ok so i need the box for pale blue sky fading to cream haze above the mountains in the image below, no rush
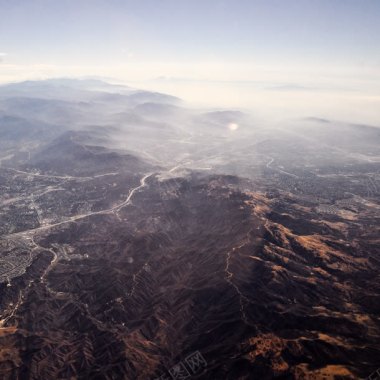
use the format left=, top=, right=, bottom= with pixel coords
left=0, top=0, right=380, bottom=124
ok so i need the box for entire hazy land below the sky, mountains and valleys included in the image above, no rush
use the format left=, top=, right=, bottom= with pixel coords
left=0, top=81, right=380, bottom=380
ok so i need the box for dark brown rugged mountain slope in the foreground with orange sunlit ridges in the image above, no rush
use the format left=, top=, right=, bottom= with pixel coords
left=0, top=175, right=380, bottom=380
